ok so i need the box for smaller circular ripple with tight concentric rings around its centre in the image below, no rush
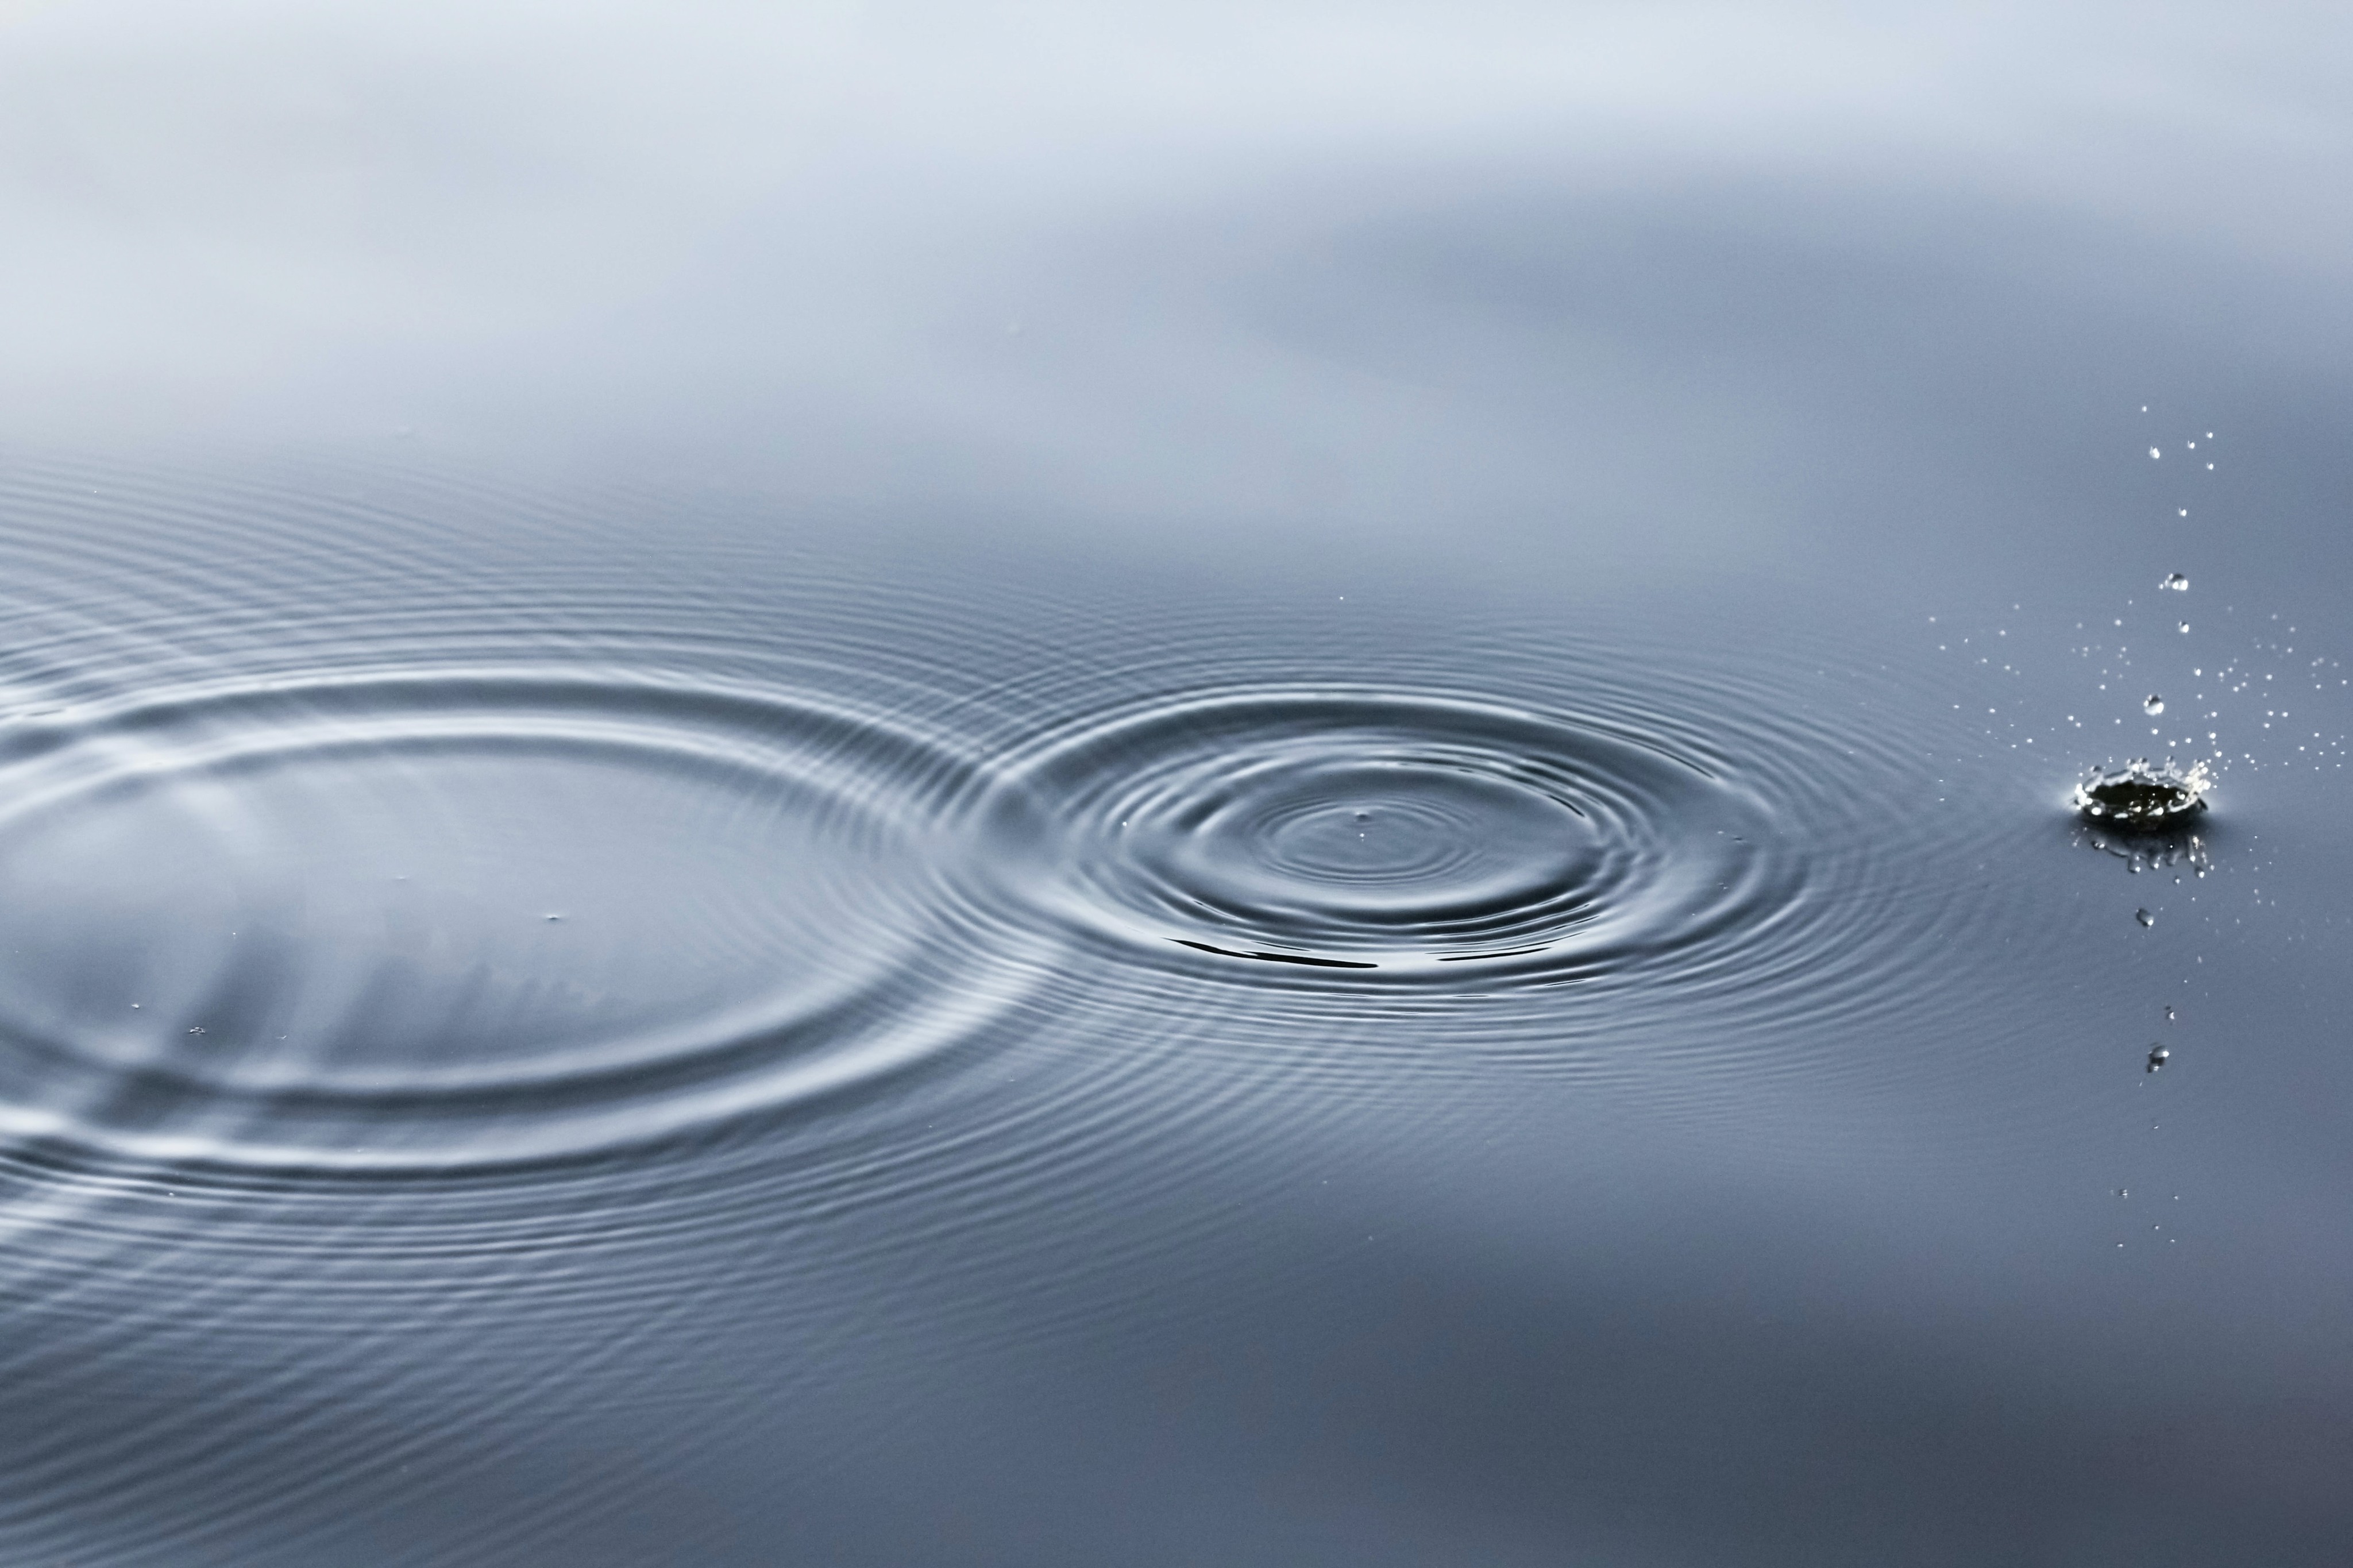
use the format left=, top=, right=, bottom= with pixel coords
left=988, top=689, right=1805, bottom=985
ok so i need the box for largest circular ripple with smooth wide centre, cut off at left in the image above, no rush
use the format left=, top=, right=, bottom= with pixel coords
left=0, top=673, right=1021, bottom=1171
